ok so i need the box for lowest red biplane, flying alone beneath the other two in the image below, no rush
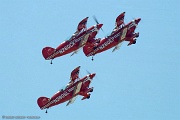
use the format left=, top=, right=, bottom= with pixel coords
left=37, top=66, right=96, bottom=113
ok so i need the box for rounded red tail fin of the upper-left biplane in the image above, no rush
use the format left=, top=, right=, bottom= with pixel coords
left=42, top=47, right=56, bottom=60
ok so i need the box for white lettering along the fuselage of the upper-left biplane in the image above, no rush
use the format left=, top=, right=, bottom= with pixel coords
left=47, top=26, right=98, bottom=60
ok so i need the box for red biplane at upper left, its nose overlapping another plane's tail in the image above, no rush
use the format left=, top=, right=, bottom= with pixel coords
left=42, top=17, right=103, bottom=64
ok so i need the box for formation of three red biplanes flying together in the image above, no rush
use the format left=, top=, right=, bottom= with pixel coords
left=37, top=12, right=141, bottom=112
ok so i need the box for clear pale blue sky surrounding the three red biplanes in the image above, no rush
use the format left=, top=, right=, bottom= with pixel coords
left=0, top=0, right=180, bottom=120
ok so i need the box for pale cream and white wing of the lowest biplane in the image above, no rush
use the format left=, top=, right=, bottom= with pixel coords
left=66, top=82, right=82, bottom=106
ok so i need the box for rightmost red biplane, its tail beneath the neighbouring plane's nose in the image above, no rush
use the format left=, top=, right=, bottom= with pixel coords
left=83, top=12, right=141, bottom=60
